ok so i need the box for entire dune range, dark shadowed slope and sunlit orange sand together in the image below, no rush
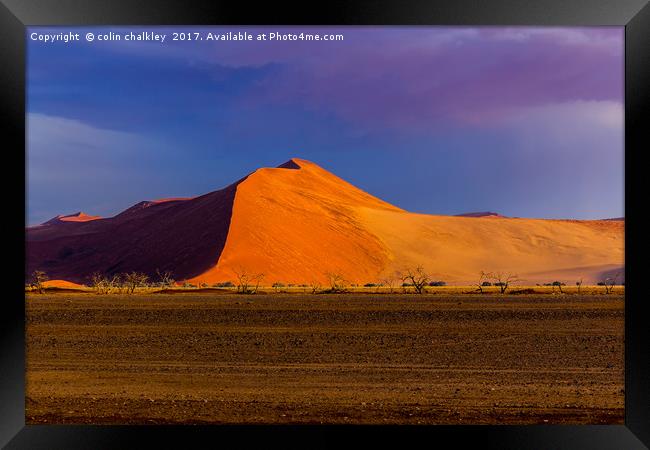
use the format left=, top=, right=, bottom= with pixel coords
left=27, top=159, right=624, bottom=284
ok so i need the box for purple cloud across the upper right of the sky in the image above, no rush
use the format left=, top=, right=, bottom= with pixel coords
left=214, top=28, right=623, bottom=133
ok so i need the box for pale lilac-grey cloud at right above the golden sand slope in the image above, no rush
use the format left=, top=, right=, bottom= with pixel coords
left=470, top=101, right=624, bottom=219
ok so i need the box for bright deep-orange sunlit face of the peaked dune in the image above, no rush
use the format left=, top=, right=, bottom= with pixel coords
left=193, top=159, right=401, bottom=283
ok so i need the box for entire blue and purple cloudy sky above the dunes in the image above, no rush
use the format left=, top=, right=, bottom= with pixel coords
left=26, top=27, right=624, bottom=225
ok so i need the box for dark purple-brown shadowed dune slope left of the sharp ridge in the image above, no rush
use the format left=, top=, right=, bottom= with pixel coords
left=27, top=183, right=236, bottom=282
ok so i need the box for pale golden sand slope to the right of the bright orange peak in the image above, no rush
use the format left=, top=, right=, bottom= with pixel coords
left=361, top=209, right=624, bottom=284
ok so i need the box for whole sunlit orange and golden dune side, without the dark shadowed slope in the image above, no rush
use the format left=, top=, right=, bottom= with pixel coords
left=186, top=159, right=624, bottom=284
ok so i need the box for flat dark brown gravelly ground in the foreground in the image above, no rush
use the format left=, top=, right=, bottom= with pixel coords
left=26, top=293, right=624, bottom=424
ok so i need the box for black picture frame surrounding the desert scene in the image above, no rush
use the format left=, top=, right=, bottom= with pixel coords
left=0, top=0, right=650, bottom=449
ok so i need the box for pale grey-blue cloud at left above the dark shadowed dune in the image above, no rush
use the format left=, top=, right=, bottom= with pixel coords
left=26, top=113, right=170, bottom=224
